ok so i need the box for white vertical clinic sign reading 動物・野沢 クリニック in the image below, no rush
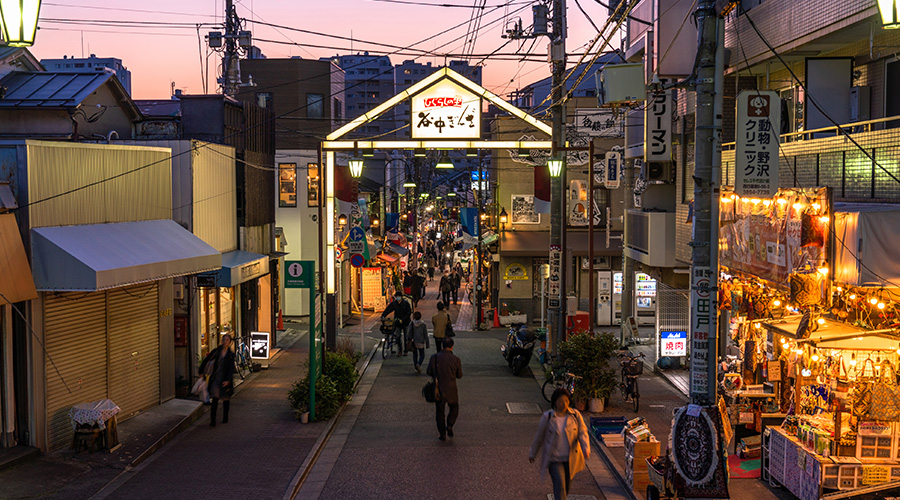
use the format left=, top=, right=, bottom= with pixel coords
left=734, top=90, right=781, bottom=198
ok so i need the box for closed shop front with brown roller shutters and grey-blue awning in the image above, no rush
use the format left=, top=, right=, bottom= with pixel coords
left=31, top=220, right=221, bottom=451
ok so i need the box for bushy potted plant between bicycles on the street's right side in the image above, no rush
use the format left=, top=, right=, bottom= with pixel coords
left=559, top=332, right=619, bottom=412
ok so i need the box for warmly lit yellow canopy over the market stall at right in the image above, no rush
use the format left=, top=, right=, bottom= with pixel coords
left=762, top=315, right=900, bottom=351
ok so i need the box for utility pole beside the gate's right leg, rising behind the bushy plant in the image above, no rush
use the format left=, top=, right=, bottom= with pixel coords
left=550, top=0, right=568, bottom=355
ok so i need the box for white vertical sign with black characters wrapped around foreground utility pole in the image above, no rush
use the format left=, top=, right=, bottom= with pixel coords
left=691, top=266, right=712, bottom=400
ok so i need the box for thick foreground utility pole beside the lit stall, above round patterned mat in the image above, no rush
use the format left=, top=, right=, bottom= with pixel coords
left=690, top=0, right=724, bottom=406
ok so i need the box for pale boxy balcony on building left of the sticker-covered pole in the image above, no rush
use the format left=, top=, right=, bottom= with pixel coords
left=625, top=210, right=675, bottom=267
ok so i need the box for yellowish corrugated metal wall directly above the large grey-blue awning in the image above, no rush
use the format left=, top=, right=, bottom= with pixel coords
left=27, top=141, right=172, bottom=227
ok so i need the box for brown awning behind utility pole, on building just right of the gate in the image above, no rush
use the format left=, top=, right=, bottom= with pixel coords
left=500, top=230, right=622, bottom=257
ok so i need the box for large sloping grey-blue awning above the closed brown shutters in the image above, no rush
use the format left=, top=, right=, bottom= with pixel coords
left=31, top=219, right=222, bottom=292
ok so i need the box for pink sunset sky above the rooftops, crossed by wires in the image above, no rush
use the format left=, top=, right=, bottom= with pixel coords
left=31, top=0, right=618, bottom=99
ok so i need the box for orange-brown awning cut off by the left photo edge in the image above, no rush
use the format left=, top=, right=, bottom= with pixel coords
left=0, top=214, right=37, bottom=305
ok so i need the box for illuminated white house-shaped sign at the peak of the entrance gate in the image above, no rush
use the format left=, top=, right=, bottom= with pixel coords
left=410, top=78, right=481, bottom=139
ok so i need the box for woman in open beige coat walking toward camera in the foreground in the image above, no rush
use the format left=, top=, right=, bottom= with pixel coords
left=528, top=389, right=591, bottom=500
